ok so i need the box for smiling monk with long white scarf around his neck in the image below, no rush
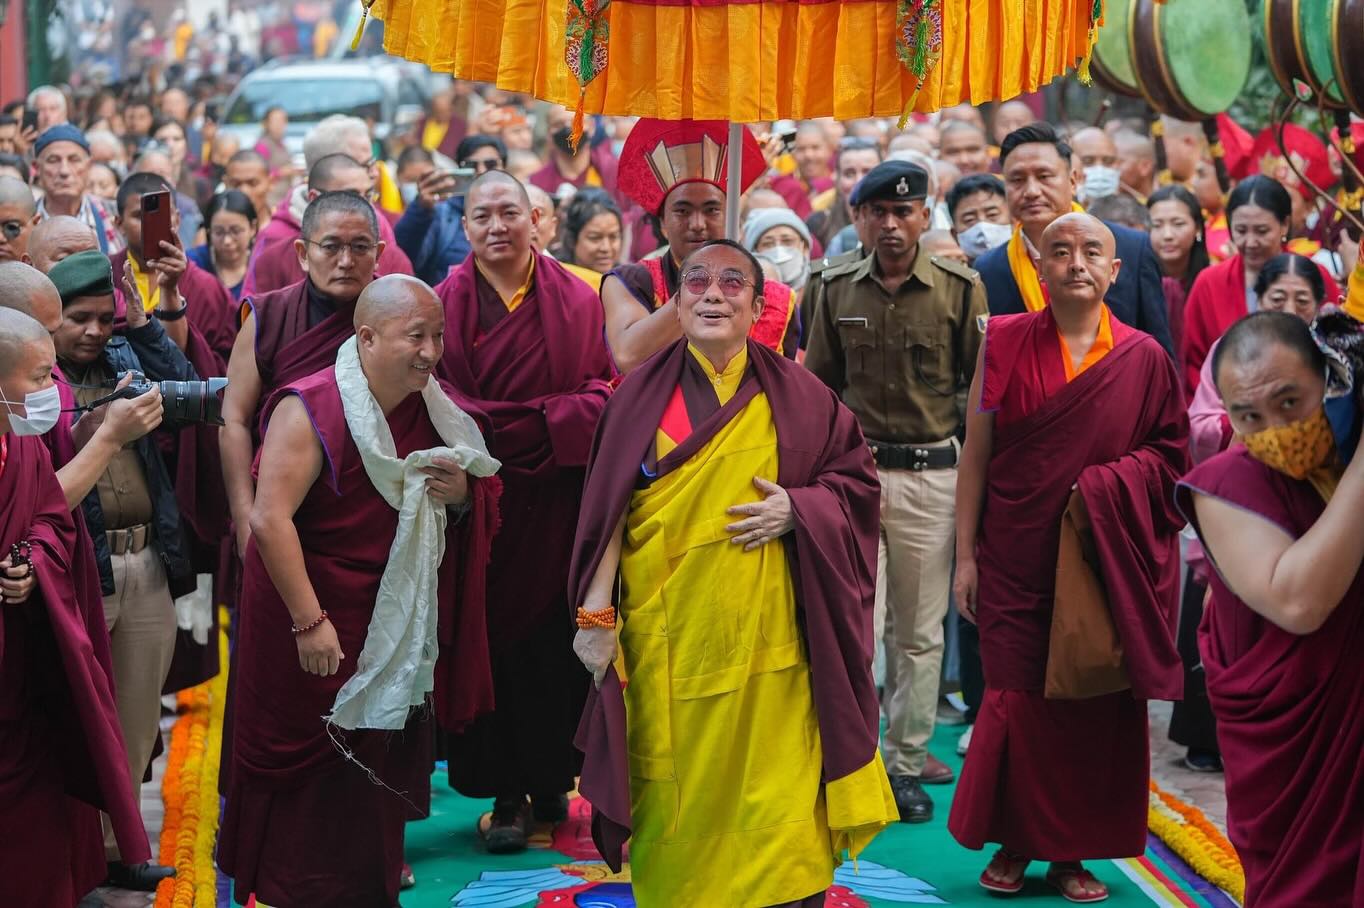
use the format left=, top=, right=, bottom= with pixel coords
left=218, top=272, right=498, bottom=908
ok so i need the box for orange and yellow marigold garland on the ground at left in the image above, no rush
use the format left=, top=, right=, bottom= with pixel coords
left=155, top=615, right=228, bottom=908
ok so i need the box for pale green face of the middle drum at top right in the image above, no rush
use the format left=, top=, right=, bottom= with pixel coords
left=1157, top=0, right=1251, bottom=116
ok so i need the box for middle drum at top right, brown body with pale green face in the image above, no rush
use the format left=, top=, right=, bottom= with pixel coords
left=1123, top=0, right=1249, bottom=120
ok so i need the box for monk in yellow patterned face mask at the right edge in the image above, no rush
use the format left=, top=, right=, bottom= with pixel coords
left=1178, top=312, right=1364, bottom=908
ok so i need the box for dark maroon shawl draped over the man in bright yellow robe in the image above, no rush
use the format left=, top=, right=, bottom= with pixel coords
left=569, top=338, right=881, bottom=868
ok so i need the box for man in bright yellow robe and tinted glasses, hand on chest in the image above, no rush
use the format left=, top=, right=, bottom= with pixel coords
left=570, top=240, right=899, bottom=908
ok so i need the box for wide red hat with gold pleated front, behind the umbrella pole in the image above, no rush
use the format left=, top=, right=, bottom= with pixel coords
left=617, top=119, right=767, bottom=215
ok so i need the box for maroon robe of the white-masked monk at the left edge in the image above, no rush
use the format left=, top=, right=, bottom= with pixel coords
left=0, top=434, right=151, bottom=908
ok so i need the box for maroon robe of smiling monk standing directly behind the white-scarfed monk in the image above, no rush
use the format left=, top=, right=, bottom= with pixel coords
left=436, top=255, right=611, bottom=640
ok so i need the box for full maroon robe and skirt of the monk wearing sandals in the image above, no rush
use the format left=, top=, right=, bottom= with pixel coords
left=948, top=308, right=1188, bottom=862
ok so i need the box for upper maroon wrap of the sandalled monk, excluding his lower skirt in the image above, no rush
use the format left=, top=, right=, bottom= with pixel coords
left=977, top=308, right=1188, bottom=699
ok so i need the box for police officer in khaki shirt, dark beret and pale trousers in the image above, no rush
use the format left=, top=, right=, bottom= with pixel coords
left=805, top=161, right=989, bottom=822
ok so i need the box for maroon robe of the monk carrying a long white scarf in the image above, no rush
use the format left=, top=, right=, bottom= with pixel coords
left=218, top=368, right=496, bottom=908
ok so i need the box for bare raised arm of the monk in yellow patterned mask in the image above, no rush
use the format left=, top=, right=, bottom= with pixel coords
left=1194, top=444, right=1364, bottom=634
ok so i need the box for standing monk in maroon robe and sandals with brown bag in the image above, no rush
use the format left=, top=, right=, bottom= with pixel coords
left=948, top=214, right=1188, bottom=901
